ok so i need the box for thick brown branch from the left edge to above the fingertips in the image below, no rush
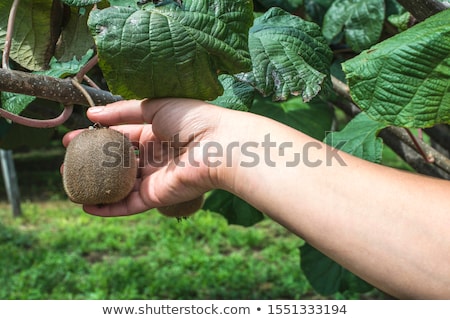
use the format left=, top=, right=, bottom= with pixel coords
left=0, top=69, right=122, bottom=106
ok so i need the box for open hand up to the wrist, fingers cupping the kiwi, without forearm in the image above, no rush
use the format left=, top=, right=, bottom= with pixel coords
left=63, top=99, right=225, bottom=216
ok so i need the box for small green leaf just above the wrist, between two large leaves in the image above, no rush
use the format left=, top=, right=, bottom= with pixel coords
left=211, top=74, right=255, bottom=111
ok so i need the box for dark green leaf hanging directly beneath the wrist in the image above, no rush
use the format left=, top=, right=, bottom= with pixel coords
left=203, top=190, right=264, bottom=227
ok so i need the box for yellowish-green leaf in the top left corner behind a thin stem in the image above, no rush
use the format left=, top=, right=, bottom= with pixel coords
left=0, top=0, right=62, bottom=70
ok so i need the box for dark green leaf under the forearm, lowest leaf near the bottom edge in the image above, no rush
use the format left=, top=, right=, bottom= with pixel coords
left=300, top=243, right=373, bottom=295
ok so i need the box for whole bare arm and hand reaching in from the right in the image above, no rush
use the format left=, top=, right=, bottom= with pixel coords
left=64, top=99, right=450, bottom=298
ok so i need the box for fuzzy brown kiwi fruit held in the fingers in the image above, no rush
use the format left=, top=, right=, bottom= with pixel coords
left=63, top=128, right=137, bottom=205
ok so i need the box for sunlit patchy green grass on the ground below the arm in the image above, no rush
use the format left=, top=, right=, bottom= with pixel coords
left=0, top=201, right=316, bottom=299
